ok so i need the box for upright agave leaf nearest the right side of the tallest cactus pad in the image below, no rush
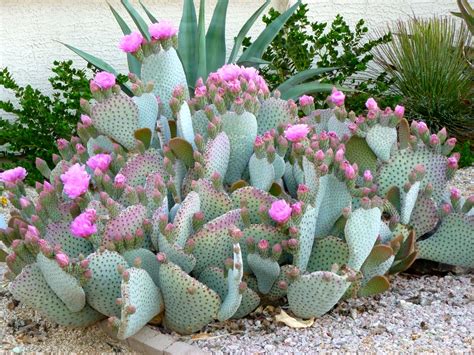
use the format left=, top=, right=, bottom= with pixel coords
left=178, top=0, right=197, bottom=86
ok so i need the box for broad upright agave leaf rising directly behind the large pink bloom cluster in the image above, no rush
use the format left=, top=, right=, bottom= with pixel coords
left=206, top=0, right=229, bottom=73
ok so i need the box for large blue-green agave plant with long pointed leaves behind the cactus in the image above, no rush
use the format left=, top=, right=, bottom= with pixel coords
left=63, top=0, right=334, bottom=97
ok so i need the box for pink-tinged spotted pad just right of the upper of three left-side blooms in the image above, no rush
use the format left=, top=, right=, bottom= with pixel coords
left=119, top=149, right=166, bottom=187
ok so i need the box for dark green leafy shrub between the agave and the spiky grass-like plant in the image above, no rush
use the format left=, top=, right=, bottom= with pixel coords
left=244, top=4, right=393, bottom=110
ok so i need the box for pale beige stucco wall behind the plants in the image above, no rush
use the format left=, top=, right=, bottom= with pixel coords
left=0, top=0, right=456, bottom=97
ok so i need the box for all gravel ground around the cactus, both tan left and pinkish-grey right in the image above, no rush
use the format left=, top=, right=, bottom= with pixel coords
left=0, top=167, right=474, bottom=354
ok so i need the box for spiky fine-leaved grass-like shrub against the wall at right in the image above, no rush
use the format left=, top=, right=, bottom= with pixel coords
left=374, top=18, right=474, bottom=142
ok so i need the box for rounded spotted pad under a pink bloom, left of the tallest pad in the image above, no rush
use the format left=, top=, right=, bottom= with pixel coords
left=91, top=94, right=139, bottom=149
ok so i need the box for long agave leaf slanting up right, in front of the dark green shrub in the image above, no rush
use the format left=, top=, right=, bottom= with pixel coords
left=237, top=0, right=301, bottom=63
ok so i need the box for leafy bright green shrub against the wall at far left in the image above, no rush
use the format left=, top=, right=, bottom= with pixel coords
left=0, top=61, right=90, bottom=183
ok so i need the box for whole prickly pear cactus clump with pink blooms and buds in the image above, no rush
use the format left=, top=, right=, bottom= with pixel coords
left=0, top=23, right=474, bottom=339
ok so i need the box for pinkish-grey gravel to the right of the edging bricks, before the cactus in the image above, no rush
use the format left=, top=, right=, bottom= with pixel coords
left=182, top=275, right=474, bottom=354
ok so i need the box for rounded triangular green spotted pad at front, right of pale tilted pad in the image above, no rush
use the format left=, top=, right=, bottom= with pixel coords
left=160, top=262, right=221, bottom=334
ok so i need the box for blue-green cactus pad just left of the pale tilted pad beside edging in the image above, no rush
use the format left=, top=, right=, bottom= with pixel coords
left=84, top=250, right=128, bottom=317
